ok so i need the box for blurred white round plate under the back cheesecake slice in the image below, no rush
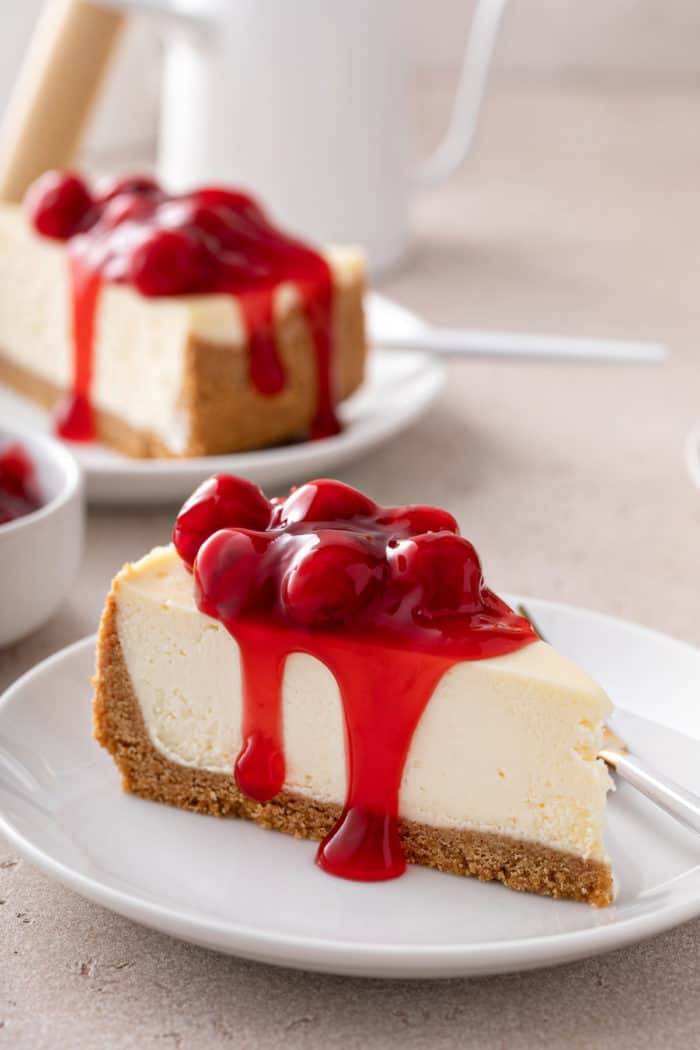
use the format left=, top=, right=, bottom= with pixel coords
left=0, top=349, right=446, bottom=504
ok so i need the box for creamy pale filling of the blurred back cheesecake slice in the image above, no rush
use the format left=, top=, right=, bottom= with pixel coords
left=0, top=205, right=363, bottom=455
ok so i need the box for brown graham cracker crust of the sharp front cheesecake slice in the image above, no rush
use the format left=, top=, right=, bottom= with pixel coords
left=93, top=591, right=613, bottom=907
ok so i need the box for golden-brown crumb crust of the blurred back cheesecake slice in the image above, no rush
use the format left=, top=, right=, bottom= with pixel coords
left=0, top=280, right=366, bottom=459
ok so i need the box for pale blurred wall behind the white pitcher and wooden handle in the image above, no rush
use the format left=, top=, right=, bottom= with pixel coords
left=8, top=0, right=700, bottom=177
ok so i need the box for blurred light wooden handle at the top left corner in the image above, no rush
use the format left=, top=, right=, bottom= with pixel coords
left=0, top=0, right=125, bottom=202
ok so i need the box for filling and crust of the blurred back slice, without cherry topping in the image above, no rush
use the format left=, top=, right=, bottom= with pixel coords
left=0, top=204, right=366, bottom=459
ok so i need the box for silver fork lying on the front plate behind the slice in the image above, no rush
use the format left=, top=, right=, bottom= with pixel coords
left=517, top=605, right=700, bottom=833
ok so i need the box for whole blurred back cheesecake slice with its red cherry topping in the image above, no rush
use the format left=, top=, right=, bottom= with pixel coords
left=0, top=173, right=365, bottom=457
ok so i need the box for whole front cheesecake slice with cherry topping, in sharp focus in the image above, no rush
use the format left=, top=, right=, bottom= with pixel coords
left=94, top=477, right=612, bottom=906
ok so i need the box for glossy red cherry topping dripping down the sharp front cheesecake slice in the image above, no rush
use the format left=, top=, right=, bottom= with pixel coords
left=173, top=475, right=536, bottom=881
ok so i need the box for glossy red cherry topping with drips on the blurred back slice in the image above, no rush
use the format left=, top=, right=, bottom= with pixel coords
left=26, top=171, right=340, bottom=441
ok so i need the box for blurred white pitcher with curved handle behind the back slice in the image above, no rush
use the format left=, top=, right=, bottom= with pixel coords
left=92, top=0, right=506, bottom=271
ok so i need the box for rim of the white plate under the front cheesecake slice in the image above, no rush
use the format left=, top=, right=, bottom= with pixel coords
left=0, top=595, right=700, bottom=978
